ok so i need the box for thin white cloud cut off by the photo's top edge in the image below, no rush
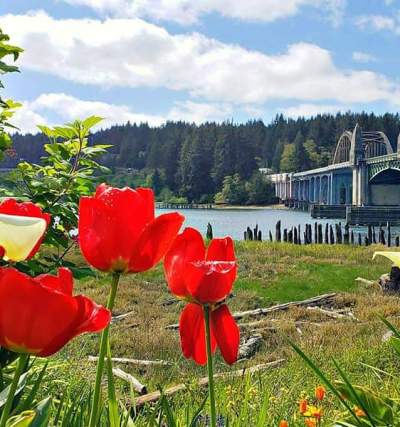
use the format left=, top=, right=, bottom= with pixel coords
left=64, top=0, right=346, bottom=25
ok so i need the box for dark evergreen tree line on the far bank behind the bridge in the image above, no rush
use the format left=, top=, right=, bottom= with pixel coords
left=1, top=112, right=400, bottom=204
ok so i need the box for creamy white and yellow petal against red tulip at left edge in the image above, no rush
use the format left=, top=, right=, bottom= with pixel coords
left=0, top=214, right=47, bottom=261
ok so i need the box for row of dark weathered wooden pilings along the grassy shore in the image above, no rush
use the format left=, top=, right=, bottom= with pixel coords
left=244, top=221, right=400, bottom=247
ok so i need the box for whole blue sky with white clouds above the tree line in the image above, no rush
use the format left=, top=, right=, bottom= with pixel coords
left=0, top=0, right=400, bottom=133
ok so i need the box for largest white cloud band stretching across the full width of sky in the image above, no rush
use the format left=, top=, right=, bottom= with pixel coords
left=0, top=12, right=400, bottom=105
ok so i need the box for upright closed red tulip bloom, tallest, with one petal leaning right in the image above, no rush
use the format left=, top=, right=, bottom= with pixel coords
left=79, top=184, right=184, bottom=273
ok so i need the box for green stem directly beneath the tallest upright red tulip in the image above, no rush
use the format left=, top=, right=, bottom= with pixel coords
left=90, top=273, right=120, bottom=427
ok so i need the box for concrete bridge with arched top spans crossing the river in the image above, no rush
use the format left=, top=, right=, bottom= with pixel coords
left=270, top=125, right=400, bottom=222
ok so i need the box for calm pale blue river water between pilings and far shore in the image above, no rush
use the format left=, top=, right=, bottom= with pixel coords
left=157, top=209, right=339, bottom=240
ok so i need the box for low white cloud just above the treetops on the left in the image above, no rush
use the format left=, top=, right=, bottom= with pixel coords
left=13, top=93, right=232, bottom=133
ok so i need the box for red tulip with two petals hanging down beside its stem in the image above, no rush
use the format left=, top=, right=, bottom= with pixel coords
left=164, top=228, right=239, bottom=365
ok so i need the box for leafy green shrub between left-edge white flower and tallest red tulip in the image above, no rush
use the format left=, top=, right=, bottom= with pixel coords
left=3, top=116, right=110, bottom=277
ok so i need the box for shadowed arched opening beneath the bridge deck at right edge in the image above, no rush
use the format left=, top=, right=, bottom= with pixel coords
left=369, top=167, right=400, bottom=206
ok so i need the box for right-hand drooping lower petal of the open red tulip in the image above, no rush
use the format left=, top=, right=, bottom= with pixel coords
left=211, top=304, right=240, bottom=365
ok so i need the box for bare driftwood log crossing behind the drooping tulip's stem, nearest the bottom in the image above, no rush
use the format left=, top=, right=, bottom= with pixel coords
left=135, top=359, right=285, bottom=407
